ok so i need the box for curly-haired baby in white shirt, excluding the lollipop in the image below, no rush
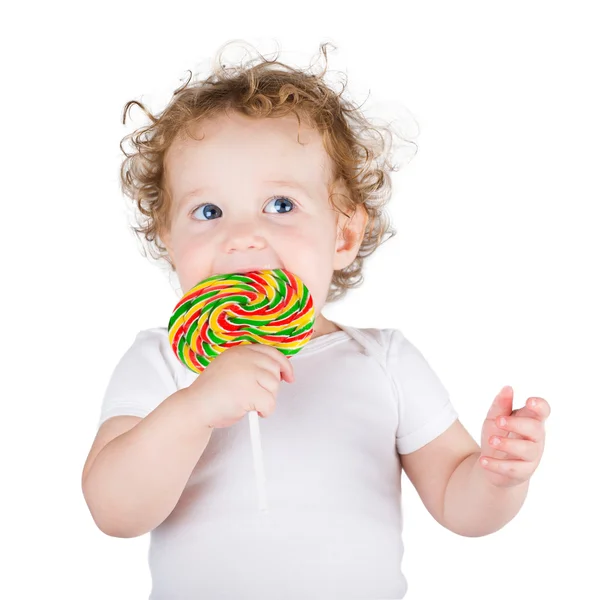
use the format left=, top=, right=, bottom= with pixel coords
left=82, top=46, right=550, bottom=600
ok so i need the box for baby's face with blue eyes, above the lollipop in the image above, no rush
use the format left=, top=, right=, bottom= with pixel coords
left=162, top=113, right=355, bottom=315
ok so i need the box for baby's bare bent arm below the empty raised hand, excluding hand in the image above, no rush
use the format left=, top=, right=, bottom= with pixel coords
left=401, top=420, right=527, bottom=537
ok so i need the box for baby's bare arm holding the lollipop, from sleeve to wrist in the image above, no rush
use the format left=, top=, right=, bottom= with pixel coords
left=82, top=390, right=213, bottom=537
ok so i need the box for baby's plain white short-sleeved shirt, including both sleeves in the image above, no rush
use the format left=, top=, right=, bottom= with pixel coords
left=99, top=323, right=458, bottom=600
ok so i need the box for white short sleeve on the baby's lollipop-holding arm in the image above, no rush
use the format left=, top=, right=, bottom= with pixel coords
left=98, top=328, right=178, bottom=427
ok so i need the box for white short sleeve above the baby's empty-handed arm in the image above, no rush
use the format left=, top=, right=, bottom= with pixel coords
left=387, top=330, right=458, bottom=454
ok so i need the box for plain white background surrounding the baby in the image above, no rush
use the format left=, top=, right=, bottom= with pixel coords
left=0, top=1, right=600, bottom=600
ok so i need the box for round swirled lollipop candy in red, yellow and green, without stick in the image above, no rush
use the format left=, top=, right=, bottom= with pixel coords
left=168, top=269, right=315, bottom=373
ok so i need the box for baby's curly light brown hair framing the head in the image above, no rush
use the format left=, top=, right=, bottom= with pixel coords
left=120, top=42, right=414, bottom=302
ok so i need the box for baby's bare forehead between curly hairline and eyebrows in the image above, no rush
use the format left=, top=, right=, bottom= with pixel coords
left=165, top=113, right=330, bottom=197
